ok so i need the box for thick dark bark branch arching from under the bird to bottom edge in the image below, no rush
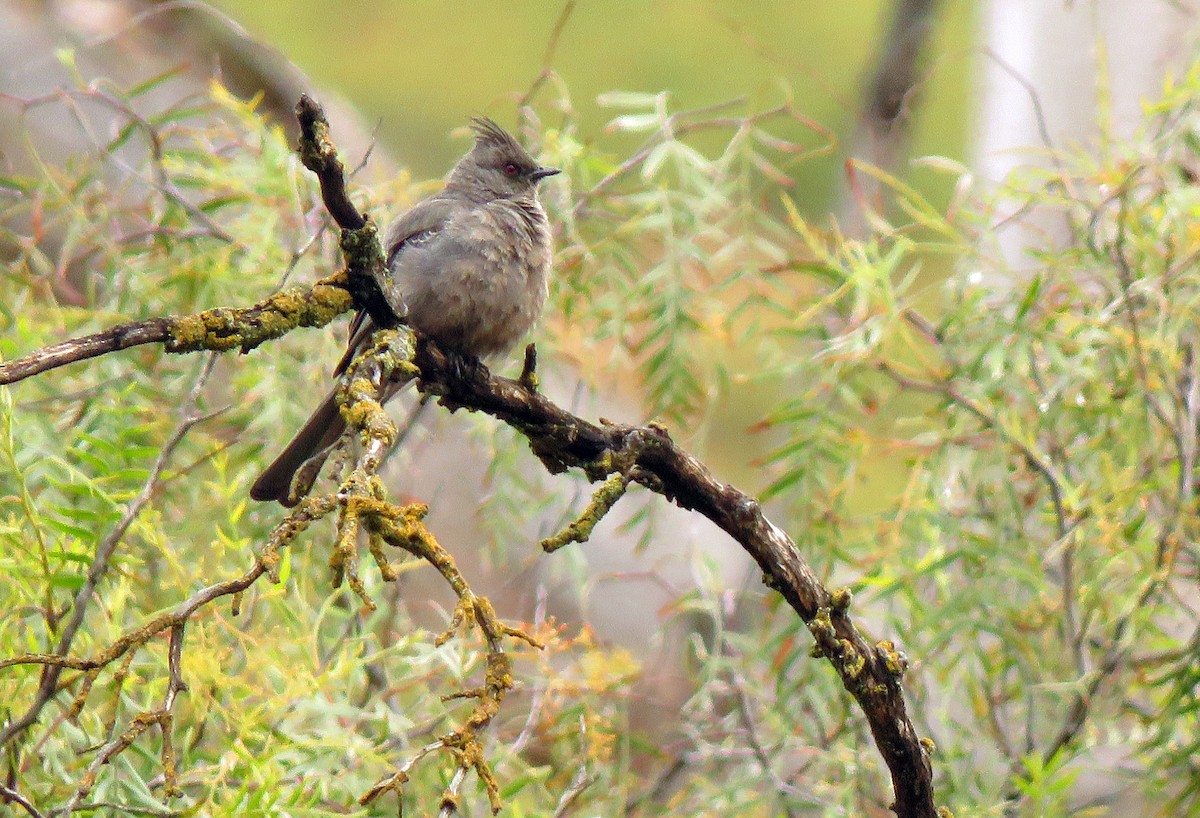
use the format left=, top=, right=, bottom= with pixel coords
left=414, top=341, right=937, bottom=818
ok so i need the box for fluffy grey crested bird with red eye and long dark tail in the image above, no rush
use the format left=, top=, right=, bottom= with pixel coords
left=250, top=119, right=558, bottom=507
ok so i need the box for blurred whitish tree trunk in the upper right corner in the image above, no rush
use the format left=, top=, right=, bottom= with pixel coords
left=972, top=0, right=1200, bottom=280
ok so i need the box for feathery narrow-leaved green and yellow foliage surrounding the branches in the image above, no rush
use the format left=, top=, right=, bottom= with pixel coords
left=0, top=36, right=1200, bottom=816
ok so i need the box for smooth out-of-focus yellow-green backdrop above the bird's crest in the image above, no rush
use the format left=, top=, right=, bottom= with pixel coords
left=206, top=0, right=974, bottom=213
